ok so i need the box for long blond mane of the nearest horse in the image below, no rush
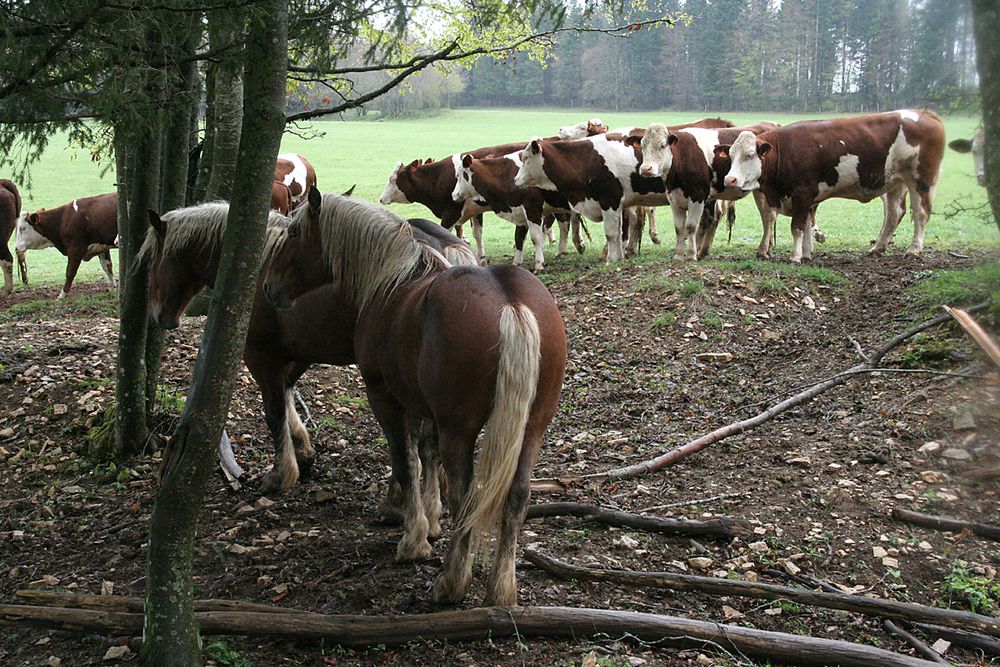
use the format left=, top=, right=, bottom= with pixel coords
left=308, top=194, right=451, bottom=311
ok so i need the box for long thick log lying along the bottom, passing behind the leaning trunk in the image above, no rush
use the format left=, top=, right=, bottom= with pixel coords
left=0, top=605, right=935, bottom=667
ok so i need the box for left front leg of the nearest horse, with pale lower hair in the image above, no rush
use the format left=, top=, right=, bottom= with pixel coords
left=368, top=383, right=431, bottom=561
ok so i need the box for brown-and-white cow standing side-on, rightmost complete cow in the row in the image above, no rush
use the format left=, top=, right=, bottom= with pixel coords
left=717, top=109, right=944, bottom=262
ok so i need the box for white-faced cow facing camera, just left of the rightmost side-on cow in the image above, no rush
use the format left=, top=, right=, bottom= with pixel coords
left=625, top=122, right=779, bottom=259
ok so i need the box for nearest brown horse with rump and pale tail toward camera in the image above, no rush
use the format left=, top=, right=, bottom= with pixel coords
left=264, top=190, right=566, bottom=605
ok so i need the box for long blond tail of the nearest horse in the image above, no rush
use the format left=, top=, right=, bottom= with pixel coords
left=459, top=304, right=542, bottom=540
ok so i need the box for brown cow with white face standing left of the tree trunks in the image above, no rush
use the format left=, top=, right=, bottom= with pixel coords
left=15, top=192, right=118, bottom=299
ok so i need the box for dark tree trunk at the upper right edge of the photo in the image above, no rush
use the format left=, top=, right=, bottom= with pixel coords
left=972, top=0, right=1000, bottom=235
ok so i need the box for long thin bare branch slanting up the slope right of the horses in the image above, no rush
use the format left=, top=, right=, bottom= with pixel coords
left=531, top=302, right=989, bottom=491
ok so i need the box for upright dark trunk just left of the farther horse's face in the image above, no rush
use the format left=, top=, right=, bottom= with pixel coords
left=115, top=116, right=160, bottom=456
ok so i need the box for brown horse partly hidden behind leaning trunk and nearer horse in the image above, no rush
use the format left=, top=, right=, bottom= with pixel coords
left=139, top=202, right=476, bottom=494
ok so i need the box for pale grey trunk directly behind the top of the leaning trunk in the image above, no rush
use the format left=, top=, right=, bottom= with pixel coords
left=205, top=9, right=245, bottom=201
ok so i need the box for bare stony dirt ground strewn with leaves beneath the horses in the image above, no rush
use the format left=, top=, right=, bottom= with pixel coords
left=0, top=248, right=1000, bottom=666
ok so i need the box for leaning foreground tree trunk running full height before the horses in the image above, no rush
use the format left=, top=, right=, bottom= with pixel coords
left=143, top=0, right=288, bottom=667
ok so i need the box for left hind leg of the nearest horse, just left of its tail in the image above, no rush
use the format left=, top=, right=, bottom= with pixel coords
left=432, top=431, right=478, bottom=604
